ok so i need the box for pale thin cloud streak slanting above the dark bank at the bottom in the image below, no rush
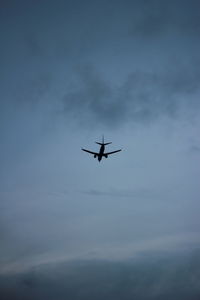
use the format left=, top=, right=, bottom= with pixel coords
left=0, top=233, right=199, bottom=274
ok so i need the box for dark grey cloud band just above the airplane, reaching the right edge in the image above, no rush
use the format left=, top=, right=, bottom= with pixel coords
left=63, top=65, right=200, bottom=126
